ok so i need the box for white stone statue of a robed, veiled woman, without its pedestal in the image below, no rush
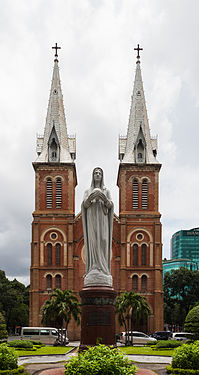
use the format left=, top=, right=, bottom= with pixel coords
left=82, top=167, right=113, bottom=286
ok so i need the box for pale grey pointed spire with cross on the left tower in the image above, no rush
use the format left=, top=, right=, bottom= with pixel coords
left=36, top=43, right=75, bottom=163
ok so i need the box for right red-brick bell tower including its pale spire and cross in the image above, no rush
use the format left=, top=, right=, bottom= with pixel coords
left=117, top=44, right=163, bottom=332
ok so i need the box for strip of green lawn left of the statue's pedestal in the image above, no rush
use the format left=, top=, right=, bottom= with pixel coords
left=15, top=346, right=72, bottom=357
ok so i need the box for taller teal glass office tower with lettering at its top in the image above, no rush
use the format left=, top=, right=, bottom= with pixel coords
left=171, top=228, right=199, bottom=266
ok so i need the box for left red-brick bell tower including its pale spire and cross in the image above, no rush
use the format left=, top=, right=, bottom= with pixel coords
left=29, top=43, right=77, bottom=326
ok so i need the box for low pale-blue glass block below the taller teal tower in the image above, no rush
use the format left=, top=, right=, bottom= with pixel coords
left=162, top=259, right=198, bottom=277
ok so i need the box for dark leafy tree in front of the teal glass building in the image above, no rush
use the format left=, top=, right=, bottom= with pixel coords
left=164, top=267, right=199, bottom=327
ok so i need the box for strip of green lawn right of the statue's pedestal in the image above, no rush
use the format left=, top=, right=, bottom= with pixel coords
left=118, top=346, right=173, bottom=357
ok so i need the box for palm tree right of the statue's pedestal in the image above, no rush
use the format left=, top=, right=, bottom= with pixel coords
left=115, top=291, right=150, bottom=345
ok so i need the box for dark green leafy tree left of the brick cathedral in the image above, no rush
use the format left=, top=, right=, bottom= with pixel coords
left=0, top=270, right=29, bottom=332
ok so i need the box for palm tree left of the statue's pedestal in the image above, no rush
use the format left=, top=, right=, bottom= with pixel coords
left=41, top=289, right=81, bottom=344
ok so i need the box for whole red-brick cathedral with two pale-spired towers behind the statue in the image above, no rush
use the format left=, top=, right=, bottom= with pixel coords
left=29, top=44, right=163, bottom=340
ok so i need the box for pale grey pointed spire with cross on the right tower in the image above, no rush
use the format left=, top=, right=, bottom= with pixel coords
left=119, top=44, right=159, bottom=164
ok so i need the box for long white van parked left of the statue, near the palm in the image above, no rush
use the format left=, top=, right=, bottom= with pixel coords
left=21, top=327, right=69, bottom=345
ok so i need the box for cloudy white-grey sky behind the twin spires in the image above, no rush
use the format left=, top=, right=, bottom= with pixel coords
left=0, top=0, right=199, bottom=284
